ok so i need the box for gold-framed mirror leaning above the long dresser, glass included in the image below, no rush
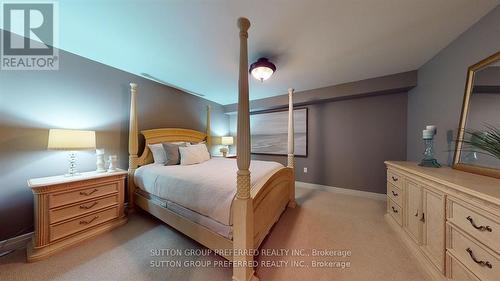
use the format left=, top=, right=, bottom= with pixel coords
left=453, top=52, right=500, bottom=178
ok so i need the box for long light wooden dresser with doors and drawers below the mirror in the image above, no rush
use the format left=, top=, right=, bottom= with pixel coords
left=385, top=161, right=500, bottom=281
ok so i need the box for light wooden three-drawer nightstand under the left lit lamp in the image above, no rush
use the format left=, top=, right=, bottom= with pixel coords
left=27, top=170, right=127, bottom=262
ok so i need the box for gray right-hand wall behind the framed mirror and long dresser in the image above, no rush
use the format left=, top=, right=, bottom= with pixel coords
left=407, top=6, right=500, bottom=164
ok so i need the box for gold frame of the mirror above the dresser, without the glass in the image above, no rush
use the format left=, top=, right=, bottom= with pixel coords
left=453, top=52, right=500, bottom=178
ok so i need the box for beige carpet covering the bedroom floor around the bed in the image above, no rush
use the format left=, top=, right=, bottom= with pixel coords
left=0, top=186, right=428, bottom=281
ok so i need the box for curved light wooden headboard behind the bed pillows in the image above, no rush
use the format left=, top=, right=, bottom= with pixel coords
left=137, top=128, right=208, bottom=166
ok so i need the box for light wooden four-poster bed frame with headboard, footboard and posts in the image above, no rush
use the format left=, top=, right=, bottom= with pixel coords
left=128, top=18, right=296, bottom=281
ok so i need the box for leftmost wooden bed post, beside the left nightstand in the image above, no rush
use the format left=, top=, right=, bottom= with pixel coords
left=128, top=83, right=139, bottom=210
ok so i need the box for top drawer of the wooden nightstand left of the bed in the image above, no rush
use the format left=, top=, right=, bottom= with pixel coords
left=49, top=182, right=118, bottom=208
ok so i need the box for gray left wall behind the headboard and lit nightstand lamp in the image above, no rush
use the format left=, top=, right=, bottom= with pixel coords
left=0, top=42, right=228, bottom=241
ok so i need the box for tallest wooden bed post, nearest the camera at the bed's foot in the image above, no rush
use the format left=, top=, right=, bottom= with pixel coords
left=233, top=18, right=259, bottom=281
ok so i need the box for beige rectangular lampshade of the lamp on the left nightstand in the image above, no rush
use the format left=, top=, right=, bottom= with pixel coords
left=48, top=129, right=95, bottom=150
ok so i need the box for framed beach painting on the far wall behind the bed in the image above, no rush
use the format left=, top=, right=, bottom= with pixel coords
left=250, top=108, right=307, bottom=156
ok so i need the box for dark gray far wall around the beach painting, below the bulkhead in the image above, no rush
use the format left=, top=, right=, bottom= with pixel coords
left=230, top=93, right=407, bottom=193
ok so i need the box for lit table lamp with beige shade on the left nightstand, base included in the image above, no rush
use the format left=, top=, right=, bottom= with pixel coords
left=47, top=129, right=95, bottom=177
